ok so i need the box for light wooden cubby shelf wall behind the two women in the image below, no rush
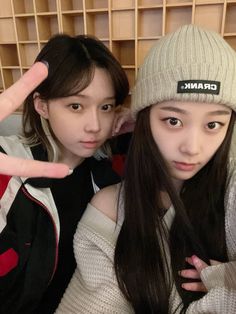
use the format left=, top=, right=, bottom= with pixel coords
left=0, top=0, right=236, bottom=106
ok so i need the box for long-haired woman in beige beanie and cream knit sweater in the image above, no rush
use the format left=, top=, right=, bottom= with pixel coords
left=57, top=25, right=236, bottom=314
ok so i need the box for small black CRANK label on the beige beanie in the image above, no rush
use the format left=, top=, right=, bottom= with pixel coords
left=177, top=80, right=220, bottom=95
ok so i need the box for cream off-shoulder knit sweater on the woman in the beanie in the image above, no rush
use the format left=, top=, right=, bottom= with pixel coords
left=56, top=163, right=236, bottom=314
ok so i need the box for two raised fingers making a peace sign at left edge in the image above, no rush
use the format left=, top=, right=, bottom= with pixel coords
left=0, top=62, right=69, bottom=178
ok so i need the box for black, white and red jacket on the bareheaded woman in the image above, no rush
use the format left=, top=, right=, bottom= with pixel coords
left=0, top=136, right=126, bottom=314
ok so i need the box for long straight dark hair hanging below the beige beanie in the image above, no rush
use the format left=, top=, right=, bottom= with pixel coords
left=115, top=107, right=235, bottom=314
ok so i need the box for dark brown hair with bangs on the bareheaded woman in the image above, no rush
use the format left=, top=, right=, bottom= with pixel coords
left=23, top=34, right=129, bottom=159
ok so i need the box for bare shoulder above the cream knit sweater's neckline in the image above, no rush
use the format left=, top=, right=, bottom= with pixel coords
left=90, top=184, right=120, bottom=222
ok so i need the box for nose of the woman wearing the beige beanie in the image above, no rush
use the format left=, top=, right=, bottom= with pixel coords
left=179, top=129, right=201, bottom=156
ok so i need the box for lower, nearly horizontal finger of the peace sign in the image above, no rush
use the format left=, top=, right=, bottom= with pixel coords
left=0, top=153, right=69, bottom=178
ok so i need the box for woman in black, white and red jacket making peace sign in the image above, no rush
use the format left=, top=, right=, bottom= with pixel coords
left=0, top=34, right=129, bottom=314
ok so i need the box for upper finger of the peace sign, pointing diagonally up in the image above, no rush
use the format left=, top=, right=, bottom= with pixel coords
left=0, top=62, right=48, bottom=121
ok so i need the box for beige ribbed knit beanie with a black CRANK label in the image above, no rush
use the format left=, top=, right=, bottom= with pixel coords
left=131, top=25, right=236, bottom=115
